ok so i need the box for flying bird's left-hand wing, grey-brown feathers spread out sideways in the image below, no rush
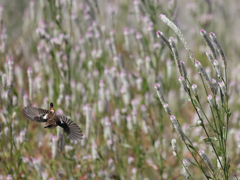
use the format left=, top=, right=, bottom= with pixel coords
left=22, top=106, right=49, bottom=122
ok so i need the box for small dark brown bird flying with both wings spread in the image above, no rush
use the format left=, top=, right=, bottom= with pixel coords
left=22, top=103, right=83, bottom=141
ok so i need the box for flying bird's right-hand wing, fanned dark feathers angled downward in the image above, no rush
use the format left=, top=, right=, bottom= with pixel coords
left=56, top=114, right=82, bottom=141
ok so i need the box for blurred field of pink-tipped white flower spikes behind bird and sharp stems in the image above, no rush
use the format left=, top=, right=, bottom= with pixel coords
left=0, top=0, right=240, bottom=180
